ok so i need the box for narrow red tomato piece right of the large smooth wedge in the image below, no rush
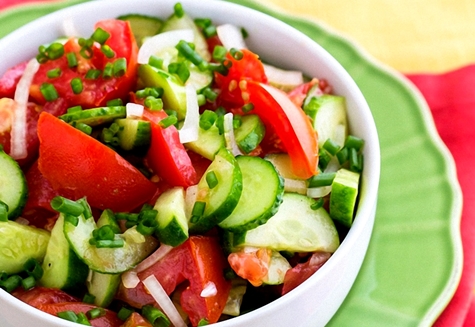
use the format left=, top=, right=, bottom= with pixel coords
left=143, top=110, right=198, bottom=187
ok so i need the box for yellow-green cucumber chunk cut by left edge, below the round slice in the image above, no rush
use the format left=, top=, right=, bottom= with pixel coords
left=0, top=221, right=50, bottom=275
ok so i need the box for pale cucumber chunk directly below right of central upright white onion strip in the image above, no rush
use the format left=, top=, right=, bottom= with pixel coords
left=184, top=125, right=226, bottom=160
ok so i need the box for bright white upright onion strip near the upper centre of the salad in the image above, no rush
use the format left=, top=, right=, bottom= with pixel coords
left=178, top=85, right=200, bottom=143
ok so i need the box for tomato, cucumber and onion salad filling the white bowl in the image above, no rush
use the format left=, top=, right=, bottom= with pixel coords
left=0, top=3, right=364, bottom=327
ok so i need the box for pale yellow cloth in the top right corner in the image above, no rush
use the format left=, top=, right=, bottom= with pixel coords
left=260, top=0, right=475, bottom=73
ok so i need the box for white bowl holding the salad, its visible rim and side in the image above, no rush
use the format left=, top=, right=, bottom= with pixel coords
left=0, top=0, right=380, bottom=327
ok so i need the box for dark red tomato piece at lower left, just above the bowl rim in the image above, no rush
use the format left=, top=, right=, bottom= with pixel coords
left=12, top=286, right=79, bottom=308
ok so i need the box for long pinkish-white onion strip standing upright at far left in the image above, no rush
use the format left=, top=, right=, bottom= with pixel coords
left=10, top=58, right=40, bottom=159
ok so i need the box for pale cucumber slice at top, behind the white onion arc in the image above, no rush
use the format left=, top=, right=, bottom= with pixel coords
left=160, top=10, right=211, bottom=61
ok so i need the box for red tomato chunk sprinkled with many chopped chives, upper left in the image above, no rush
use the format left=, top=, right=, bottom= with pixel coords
left=30, top=19, right=138, bottom=108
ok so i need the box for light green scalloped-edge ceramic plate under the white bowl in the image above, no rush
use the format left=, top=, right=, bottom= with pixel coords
left=0, top=0, right=462, bottom=326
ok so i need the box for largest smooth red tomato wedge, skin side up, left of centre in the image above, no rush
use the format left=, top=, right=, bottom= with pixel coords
left=38, top=112, right=157, bottom=211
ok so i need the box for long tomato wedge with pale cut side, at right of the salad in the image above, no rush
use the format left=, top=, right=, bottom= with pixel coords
left=246, top=81, right=318, bottom=179
